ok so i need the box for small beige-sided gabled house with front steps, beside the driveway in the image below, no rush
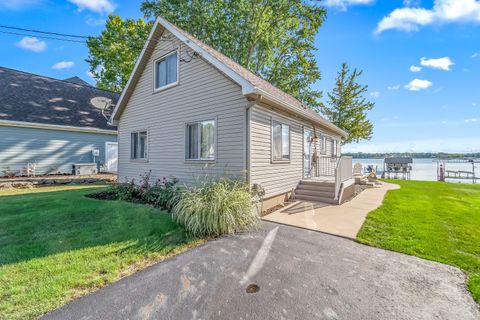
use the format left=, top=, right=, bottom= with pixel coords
left=111, top=17, right=353, bottom=208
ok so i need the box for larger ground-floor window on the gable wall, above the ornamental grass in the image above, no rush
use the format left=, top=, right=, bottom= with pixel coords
left=185, top=120, right=215, bottom=161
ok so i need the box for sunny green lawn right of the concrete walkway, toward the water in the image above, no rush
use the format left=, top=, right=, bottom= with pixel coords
left=357, top=181, right=480, bottom=302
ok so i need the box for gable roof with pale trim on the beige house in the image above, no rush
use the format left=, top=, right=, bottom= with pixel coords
left=110, top=17, right=347, bottom=136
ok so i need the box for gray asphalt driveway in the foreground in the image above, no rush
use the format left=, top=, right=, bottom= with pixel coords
left=45, top=223, right=480, bottom=320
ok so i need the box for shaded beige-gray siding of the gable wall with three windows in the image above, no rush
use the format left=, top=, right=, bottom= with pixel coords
left=118, top=30, right=247, bottom=183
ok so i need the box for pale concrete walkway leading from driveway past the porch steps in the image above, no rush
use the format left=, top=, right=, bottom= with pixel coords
left=262, top=182, right=400, bottom=239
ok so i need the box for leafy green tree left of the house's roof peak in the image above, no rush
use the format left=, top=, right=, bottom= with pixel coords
left=86, top=15, right=152, bottom=92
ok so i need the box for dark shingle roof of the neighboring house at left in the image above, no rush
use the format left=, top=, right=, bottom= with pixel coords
left=0, top=67, right=119, bottom=130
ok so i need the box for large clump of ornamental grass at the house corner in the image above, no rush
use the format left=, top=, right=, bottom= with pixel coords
left=172, top=179, right=258, bottom=236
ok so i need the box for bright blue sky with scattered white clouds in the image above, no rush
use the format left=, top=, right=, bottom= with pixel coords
left=0, top=0, right=480, bottom=152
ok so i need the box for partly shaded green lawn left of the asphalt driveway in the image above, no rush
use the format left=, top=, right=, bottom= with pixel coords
left=0, top=186, right=200, bottom=319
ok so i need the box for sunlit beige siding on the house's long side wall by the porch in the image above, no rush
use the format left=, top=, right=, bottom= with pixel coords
left=250, top=105, right=340, bottom=198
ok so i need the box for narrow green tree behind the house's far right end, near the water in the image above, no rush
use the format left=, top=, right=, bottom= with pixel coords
left=322, top=63, right=375, bottom=143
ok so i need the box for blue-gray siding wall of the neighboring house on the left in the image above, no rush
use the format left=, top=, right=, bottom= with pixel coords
left=0, top=126, right=117, bottom=176
